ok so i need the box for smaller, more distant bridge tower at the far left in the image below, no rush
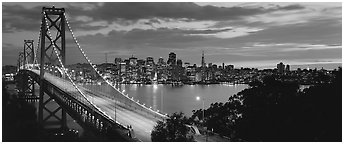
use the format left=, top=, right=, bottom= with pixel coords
left=21, top=40, right=37, bottom=99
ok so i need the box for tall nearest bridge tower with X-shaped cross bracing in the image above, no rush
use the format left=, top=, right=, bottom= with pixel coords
left=38, top=7, right=67, bottom=129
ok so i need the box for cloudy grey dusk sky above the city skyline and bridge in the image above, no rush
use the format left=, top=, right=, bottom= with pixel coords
left=2, top=2, right=342, bottom=67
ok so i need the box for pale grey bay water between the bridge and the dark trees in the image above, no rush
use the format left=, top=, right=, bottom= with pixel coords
left=107, top=84, right=248, bottom=116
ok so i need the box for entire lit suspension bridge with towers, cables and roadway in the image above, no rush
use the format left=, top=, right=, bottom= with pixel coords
left=17, top=7, right=168, bottom=141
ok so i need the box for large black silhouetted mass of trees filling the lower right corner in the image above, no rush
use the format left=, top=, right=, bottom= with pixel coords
left=192, top=69, right=342, bottom=141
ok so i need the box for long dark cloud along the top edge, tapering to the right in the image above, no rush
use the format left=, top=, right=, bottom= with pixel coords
left=76, top=2, right=303, bottom=21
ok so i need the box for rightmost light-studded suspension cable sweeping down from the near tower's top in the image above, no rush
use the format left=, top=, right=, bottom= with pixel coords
left=64, top=13, right=167, bottom=117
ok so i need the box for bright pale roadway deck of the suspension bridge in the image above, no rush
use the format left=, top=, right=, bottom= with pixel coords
left=31, top=70, right=163, bottom=142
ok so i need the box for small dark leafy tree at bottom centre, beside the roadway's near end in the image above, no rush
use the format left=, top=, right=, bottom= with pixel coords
left=151, top=112, right=194, bottom=142
